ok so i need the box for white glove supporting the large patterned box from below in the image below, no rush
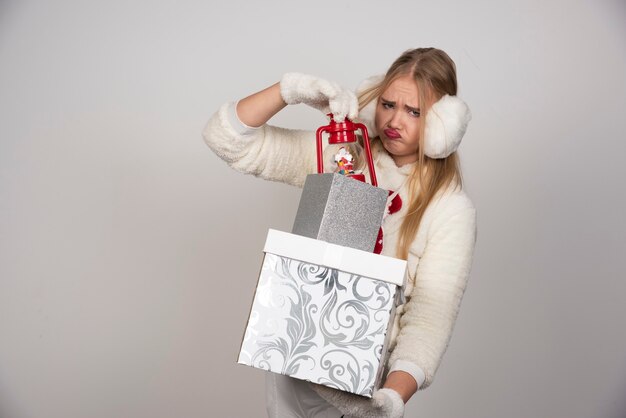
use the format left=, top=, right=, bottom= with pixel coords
left=311, top=383, right=404, bottom=418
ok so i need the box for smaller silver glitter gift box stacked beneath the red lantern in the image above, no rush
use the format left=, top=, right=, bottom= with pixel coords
left=292, top=174, right=388, bottom=252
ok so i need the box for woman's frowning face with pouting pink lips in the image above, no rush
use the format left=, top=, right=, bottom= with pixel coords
left=375, top=74, right=422, bottom=167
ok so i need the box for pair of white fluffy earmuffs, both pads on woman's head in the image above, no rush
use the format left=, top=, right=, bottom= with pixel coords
left=356, top=75, right=472, bottom=158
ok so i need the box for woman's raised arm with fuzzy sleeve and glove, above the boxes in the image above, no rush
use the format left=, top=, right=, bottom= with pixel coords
left=203, top=73, right=358, bottom=186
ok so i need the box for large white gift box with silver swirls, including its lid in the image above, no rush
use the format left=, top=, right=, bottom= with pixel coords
left=238, top=230, right=406, bottom=397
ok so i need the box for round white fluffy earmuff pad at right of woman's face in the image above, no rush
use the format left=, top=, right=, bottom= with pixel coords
left=424, top=94, right=472, bottom=158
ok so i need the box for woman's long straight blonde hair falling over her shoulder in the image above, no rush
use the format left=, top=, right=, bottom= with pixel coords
left=359, top=48, right=463, bottom=260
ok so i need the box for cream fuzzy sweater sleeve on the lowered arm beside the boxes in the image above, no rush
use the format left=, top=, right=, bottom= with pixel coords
left=389, top=202, right=476, bottom=389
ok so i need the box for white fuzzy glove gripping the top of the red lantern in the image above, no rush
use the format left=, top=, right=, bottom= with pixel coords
left=280, top=73, right=359, bottom=122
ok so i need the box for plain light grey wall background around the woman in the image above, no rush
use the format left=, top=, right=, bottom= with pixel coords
left=0, top=0, right=626, bottom=418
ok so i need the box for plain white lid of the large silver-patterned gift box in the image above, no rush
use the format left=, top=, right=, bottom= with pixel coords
left=263, top=229, right=407, bottom=287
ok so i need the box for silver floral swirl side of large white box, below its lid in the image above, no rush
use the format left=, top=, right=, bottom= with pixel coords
left=239, top=253, right=396, bottom=396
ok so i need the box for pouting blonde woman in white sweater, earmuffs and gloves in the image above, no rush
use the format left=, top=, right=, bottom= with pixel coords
left=204, top=48, right=476, bottom=418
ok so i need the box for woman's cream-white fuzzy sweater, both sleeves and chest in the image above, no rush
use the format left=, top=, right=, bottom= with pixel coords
left=203, top=103, right=476, bottom=389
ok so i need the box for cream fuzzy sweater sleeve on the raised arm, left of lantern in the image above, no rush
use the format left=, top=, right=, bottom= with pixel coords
left=203, top=103, right=316, bottom=187
